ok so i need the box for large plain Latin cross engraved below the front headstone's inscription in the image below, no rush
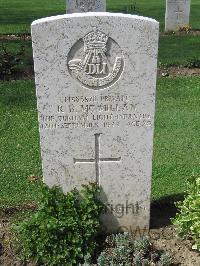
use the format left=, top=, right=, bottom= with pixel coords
left=74, top=133, right=121, bottom=186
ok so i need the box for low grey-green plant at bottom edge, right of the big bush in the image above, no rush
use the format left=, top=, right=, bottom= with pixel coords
left=97, top=233, right=172, bottom=266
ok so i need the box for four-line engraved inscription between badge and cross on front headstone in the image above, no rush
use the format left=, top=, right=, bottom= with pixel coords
left=40, top=95, right=152, bottom=130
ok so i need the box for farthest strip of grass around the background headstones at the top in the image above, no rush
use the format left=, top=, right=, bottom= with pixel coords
left=0, top=0, right=200, bottom=34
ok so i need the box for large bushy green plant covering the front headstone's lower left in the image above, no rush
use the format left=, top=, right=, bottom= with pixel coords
left=14, top=184, right=104, bottom=266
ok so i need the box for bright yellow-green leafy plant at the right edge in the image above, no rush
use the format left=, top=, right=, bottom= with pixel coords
left=172, top=176, right=200, bottom=251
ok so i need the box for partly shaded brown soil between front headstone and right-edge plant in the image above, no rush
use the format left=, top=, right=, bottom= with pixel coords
left=149, top=194, right=200, bottom=266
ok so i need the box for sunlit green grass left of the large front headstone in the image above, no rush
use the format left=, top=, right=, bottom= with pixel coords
left=0, top=81, right=42, bottom=207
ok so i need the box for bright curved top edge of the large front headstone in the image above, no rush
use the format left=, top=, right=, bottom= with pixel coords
left=31, top=12, right=159, bottom=26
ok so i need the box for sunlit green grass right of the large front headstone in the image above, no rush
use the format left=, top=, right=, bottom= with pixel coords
left=152, top=77, right=200, bottom=199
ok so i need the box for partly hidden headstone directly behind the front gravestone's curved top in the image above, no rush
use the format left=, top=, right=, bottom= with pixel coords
left=67, top=0, right=106, bottom=13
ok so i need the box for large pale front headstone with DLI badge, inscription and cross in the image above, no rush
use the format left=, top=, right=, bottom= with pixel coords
left=32, top=13, right=159, bottom=231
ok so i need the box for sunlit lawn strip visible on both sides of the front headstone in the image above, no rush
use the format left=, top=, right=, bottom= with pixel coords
left=0, top=78, right=200, bottom=208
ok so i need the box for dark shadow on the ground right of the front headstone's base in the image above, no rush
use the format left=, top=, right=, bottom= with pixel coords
left=150, top=193, right=185, bottom=229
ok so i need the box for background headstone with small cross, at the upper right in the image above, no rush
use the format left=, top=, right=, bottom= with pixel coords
left=165, top=0, right=191, bottom=31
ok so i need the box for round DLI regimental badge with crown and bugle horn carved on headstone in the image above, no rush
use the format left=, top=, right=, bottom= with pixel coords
left=67, top=29, right=124, bottom=90
